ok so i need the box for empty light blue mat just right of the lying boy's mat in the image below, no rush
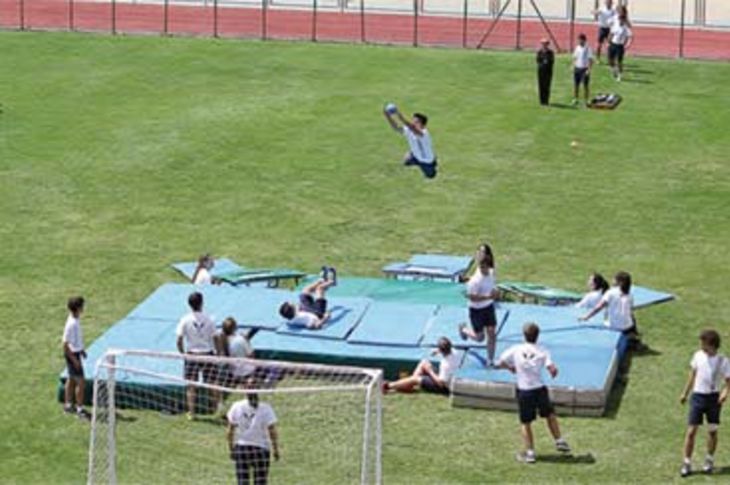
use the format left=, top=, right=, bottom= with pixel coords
left=347, top=301, right=438, bottom=346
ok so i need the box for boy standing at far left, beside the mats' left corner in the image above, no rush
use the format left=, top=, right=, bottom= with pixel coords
left=61, top=296, right=91, bottom=419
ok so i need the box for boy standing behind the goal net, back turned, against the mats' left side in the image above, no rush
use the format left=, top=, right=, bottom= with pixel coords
left=176, top=291, right=220, bottom=420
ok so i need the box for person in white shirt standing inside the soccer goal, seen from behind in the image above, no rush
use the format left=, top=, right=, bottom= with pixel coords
left=226, top=382, right=279, bottom=485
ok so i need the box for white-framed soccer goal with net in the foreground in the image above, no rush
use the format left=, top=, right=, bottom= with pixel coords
left=88, top=350, right=382, bottom=484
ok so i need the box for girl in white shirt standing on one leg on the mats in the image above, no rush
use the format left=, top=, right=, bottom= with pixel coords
left=459, top=244, right=499, bottom=366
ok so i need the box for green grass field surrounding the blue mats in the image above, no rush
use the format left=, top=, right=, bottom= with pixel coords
left=0, top=32, right=730, bottom=484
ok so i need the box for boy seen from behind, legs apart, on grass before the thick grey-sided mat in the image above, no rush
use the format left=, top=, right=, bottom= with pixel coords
left=497, top=323, right=570, bottom=463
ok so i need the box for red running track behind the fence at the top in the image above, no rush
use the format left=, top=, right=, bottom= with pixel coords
left=0, top=0, right=730, bottom=60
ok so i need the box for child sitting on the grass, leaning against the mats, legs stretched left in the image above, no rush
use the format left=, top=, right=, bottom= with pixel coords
left=383, top=337, right=459, bottom=395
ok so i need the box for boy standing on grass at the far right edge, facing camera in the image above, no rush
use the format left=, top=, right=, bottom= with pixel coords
left=679, top=330, right=730, bottom=477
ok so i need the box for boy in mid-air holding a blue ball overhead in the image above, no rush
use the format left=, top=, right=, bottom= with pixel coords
left=383, top=104, right=438, bottom=179
